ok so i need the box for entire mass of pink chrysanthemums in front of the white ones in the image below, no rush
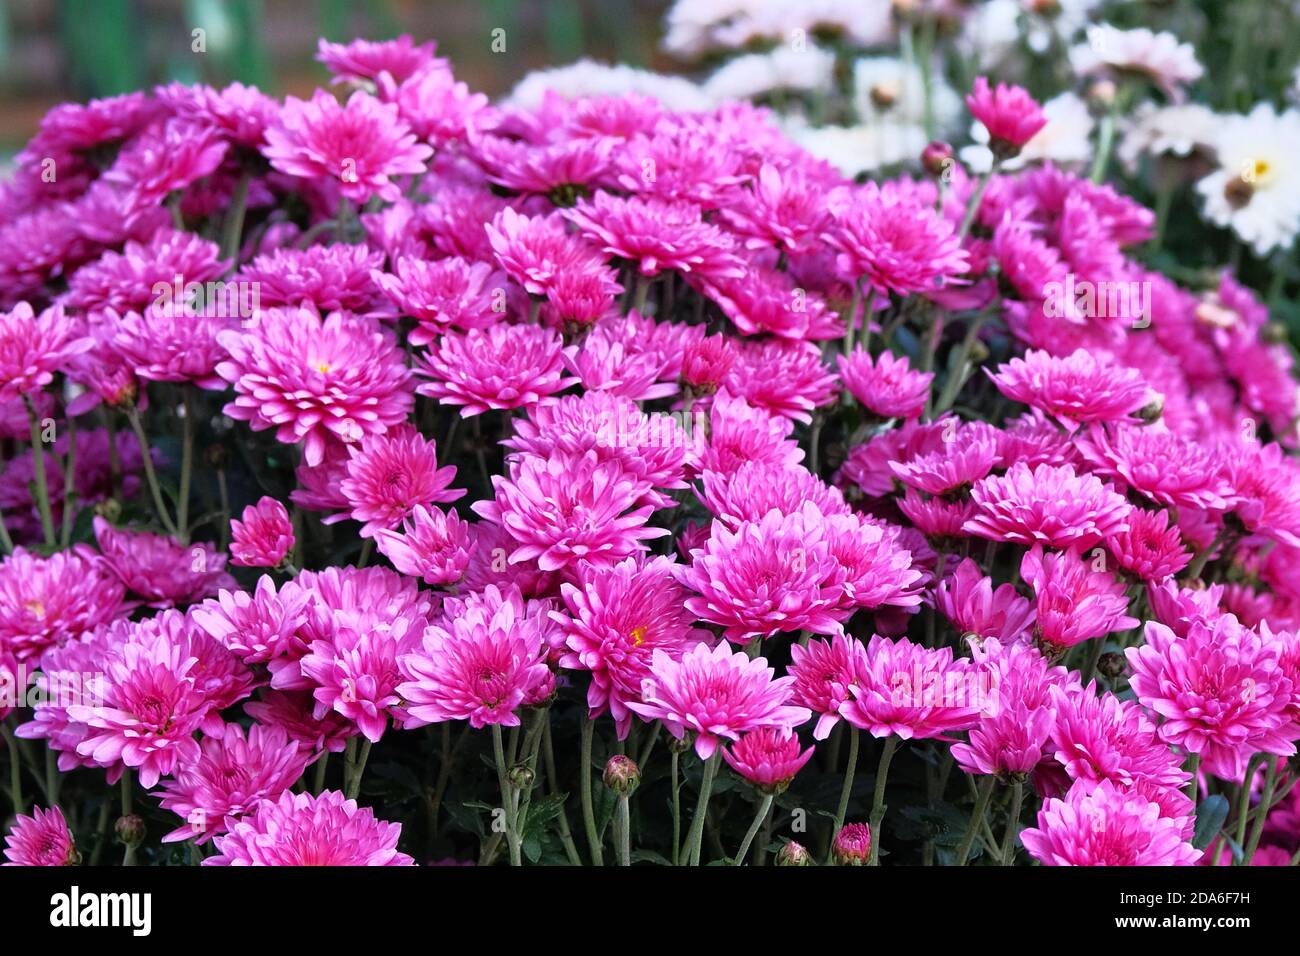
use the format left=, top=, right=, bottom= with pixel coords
left=0, top=29, right=1300, bottom=865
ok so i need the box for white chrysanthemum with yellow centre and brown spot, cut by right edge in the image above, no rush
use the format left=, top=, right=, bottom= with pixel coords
left=1196, top=103, right=1300, bottom=256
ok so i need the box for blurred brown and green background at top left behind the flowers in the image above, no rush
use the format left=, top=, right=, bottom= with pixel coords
left=0, top=0, right=671, bottom=156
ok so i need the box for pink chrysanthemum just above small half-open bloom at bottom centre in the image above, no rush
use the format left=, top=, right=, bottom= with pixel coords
left=628, top=641, right=811, bottom=760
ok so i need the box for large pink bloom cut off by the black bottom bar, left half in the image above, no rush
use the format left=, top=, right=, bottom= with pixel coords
left=203, top=790, right=415, bottom=866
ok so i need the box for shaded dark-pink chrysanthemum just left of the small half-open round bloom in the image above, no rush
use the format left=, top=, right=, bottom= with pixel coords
left=95, top=515, right=238, bottom=607
